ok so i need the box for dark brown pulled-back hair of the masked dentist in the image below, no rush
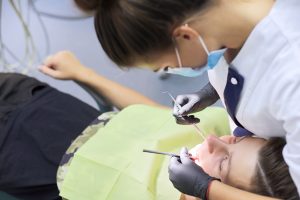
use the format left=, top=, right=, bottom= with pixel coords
left=95, top=0, right=212, bottom=66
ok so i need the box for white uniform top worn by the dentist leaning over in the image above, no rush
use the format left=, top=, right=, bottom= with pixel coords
left=208, top=0, right=300, bottom=194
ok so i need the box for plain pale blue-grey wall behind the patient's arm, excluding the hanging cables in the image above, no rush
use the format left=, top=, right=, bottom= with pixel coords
left=1, top=0, right=211, bottom=109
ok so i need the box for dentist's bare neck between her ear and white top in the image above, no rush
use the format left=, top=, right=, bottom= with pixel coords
left=195, top=0, right=274, bottom=49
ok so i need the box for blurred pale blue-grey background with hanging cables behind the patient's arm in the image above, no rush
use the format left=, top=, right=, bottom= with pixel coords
left=0, top=0, right=208, bottom=107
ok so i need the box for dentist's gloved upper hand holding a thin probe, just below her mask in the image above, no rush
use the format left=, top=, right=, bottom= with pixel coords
left=173, top=83, right=219, bottom=125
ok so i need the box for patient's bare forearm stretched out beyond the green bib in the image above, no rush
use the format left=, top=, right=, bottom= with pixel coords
left=75, top=68, right=167, bottom=109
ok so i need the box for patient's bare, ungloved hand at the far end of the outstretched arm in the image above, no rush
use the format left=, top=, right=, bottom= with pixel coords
left=39, top=51, right=92, bottom=81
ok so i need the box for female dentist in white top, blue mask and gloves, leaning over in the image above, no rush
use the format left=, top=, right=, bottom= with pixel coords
left=95, top=0, right=300, bottom=200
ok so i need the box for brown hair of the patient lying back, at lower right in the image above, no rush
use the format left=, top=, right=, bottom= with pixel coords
left=251, top=138, right=299, bottom=200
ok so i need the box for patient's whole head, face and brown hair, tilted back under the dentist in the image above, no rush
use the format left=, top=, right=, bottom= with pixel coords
left=181, top=136, right=299, bottom=199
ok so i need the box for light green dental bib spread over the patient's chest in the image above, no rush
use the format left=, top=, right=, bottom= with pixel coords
left=60, top=105, right=230, bottom=200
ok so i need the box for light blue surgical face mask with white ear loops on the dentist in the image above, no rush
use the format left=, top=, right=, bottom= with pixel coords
left=167, top=36, right=227, bottom=77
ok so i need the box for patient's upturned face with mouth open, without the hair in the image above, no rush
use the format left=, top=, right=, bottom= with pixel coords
left=191, top=136, right=266, bottom=189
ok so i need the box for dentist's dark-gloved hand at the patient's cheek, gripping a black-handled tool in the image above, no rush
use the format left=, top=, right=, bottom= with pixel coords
left=169, top=148, right=217, bottom=200
